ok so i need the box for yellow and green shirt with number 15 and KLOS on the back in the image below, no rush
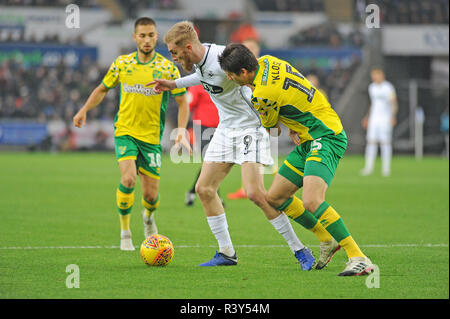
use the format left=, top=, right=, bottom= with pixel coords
left=251, top=55, right=343, bottom=143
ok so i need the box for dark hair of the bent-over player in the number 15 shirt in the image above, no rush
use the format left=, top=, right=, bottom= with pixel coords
left=219, top=43, right=258, bottom=75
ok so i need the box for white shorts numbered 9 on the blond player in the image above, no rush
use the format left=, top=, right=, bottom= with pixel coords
left=203, top=126, right=273, bottom=165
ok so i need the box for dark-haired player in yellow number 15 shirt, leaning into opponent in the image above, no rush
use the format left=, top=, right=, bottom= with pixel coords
left=219, top=44, right=373, bottom=276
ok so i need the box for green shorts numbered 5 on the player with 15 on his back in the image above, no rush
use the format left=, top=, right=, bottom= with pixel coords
left=278, top=131, right=347, bottom=187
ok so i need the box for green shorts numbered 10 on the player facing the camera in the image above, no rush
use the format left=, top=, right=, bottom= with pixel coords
left=114, top=135, right=162, bottom=179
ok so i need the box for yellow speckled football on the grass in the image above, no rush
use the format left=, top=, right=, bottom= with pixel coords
left=141, top=234, right=175, bottom=266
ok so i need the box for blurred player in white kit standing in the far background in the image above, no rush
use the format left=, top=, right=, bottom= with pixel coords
left=361, top=68, right=398, bottom=176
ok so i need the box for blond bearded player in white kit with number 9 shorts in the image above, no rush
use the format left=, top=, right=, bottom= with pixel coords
left=147, top=21, right=315, bottom=270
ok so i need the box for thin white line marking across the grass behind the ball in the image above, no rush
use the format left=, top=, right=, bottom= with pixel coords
left=0, top=244, right=448, bottom=250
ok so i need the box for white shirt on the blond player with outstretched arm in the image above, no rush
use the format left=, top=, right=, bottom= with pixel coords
left=175, top=43, right=261, bottom=129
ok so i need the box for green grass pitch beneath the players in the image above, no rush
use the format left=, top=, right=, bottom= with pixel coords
left=0, top=152, right=449, bottom=299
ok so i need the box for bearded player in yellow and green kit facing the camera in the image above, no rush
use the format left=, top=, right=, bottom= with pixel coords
left=73, top=17, right=190, bottom=250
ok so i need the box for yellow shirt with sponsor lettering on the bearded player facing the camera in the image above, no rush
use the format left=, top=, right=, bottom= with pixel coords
left=102, top=52, right=186, bottom=145
